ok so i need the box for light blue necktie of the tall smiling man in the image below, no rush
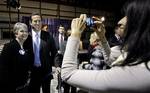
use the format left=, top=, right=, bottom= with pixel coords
left=34, top=34, right=41, bottom=67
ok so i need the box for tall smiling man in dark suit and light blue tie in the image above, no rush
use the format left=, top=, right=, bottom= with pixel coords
left=26, top=13, right=57, bottom=93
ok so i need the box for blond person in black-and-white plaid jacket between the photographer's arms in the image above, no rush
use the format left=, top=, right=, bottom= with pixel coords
left=82, top=32, right=109, bottom=70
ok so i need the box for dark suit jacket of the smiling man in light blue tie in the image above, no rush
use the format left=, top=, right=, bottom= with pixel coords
left=25, top=31, right=57, bottom=78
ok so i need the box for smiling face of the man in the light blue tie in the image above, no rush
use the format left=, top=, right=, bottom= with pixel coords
left=31, top=15, right=42, bottom=31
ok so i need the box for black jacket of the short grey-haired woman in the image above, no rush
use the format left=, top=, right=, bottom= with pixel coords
left=0, top=39, right=31, bottom=93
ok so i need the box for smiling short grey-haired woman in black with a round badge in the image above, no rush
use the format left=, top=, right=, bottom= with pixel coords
left=0, top=22, right=31, bottom=93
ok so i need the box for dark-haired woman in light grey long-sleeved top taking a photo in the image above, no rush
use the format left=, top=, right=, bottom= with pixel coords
left=61, top=0, right=150, bottom=93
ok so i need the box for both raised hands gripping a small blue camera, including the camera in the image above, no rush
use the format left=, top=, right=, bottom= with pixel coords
left=71, top=14, right=105, bottom=40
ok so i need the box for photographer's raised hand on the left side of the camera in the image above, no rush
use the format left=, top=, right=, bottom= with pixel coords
left=71, top=14, right=87, bottom=38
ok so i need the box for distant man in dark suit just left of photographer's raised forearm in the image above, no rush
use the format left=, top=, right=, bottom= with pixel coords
left=54, top=25, right=66, bottom=92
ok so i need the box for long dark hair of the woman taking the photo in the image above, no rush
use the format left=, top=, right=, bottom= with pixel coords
left=122, top=0, right=150, bottom=65
